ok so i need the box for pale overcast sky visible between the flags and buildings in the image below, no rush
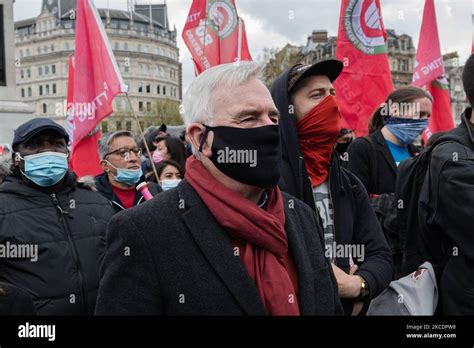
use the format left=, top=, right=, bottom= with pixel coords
left=14, top=0, right=474, bottom=92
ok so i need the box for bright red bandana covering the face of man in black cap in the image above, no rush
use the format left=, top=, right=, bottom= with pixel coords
left=296, top=95, right=341, bottom=187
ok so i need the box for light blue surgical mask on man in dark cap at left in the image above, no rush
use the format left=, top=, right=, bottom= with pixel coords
left=17, top=152, right=68, bottom=187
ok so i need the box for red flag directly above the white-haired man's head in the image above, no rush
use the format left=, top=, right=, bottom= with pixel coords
left=182, top=0, right=252, bottom=74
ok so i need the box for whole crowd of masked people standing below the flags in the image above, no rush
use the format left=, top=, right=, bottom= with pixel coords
left=0, top=55, right=474, bottom=316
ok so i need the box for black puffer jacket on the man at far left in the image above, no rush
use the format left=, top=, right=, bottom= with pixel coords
left=0, top=172, right=114, bottom=315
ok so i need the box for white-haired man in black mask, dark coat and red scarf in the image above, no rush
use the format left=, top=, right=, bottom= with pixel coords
left=96, top=62, right=342, bottom=315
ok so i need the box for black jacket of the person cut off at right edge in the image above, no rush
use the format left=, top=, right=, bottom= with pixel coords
left=418, top=108, right=474, bottom=315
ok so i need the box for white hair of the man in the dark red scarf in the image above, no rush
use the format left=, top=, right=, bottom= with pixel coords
left=182, top=61, right=264, bottom=153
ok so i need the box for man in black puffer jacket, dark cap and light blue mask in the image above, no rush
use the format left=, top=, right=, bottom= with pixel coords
left=0, top=118, right=114, bottom=315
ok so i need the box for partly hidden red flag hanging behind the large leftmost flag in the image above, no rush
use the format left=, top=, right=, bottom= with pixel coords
left=66, top=56, right=102, bottom=178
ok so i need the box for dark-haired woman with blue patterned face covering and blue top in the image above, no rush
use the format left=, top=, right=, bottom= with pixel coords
left=344, top=86, right=433, bottom=195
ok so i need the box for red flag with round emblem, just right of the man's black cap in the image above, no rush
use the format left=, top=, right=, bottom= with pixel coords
left=334, top=0, right=393, bottom=136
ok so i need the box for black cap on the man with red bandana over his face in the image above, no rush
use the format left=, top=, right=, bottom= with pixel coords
left=288, top=59, right=344, bottom=92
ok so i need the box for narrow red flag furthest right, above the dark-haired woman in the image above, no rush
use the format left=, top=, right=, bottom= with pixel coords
left=412, top=0, right=454, bottom=141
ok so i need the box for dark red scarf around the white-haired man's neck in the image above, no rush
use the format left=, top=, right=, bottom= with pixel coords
left=186, top=156, right=300, bottom=315
